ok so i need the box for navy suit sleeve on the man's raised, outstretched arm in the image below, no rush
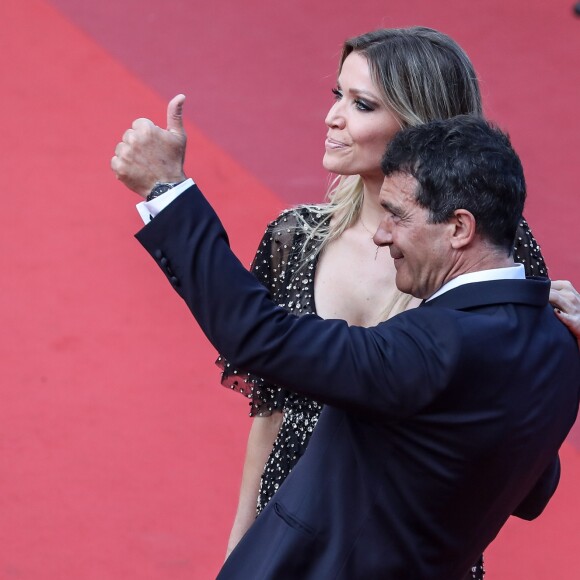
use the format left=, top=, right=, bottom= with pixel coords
left=137, top=186, right=461, bottom=419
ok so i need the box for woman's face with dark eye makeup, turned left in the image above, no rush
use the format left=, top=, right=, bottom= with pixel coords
left=322, top=52, right=401, bottom=181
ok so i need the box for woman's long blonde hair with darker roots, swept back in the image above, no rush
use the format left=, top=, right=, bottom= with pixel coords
left=300, top=26, right=482, bottom=320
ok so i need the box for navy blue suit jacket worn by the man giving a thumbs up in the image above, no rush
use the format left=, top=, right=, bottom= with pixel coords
left=137, top=186, right=580, bottom=580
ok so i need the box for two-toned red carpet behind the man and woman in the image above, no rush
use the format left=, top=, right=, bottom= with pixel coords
left=0, top=0, right=580, bottom=580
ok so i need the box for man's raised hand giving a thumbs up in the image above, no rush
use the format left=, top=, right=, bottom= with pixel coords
left=111, top=95, right=187, bottom=197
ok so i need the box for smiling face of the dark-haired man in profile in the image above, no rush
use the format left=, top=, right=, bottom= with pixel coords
left=374, top=173, right=453, bottom=299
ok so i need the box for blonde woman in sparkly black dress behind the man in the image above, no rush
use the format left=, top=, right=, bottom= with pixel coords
left=218, top=27, right=547, bottom=578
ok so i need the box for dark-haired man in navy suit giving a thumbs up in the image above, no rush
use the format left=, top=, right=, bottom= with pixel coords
left=112, top=98, right=580, bottom=580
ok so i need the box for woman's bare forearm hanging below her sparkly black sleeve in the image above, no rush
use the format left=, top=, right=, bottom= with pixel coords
left=226, top=411, right=282, bottom=558
